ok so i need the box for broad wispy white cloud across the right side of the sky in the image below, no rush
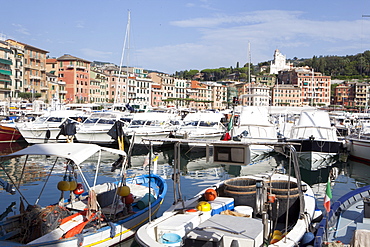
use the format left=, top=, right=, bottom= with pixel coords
left=140, top=10, right=370, bottom=73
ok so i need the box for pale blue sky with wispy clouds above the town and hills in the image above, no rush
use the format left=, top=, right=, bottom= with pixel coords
left=0, top=0, right=370, bottom=74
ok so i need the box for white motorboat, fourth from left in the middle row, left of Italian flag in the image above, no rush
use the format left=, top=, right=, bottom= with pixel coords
left=174, top=112, right=226, bottom=145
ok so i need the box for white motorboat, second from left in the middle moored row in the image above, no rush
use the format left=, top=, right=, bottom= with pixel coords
left=76, top=112, right=132, bottom=144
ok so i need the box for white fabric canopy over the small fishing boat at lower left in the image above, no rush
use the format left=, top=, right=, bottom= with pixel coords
left=0, top=143, right=126, bottom=165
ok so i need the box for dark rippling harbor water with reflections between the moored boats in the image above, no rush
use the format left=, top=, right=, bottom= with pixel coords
left=0, top=143, right=370, bottom=246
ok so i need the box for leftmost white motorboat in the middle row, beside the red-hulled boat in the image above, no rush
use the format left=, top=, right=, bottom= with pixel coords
left=17, top=110, right=89, bottom=144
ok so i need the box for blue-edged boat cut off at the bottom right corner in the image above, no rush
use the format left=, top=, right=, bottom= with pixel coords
left=314, top=185, right=370, bottom=247
